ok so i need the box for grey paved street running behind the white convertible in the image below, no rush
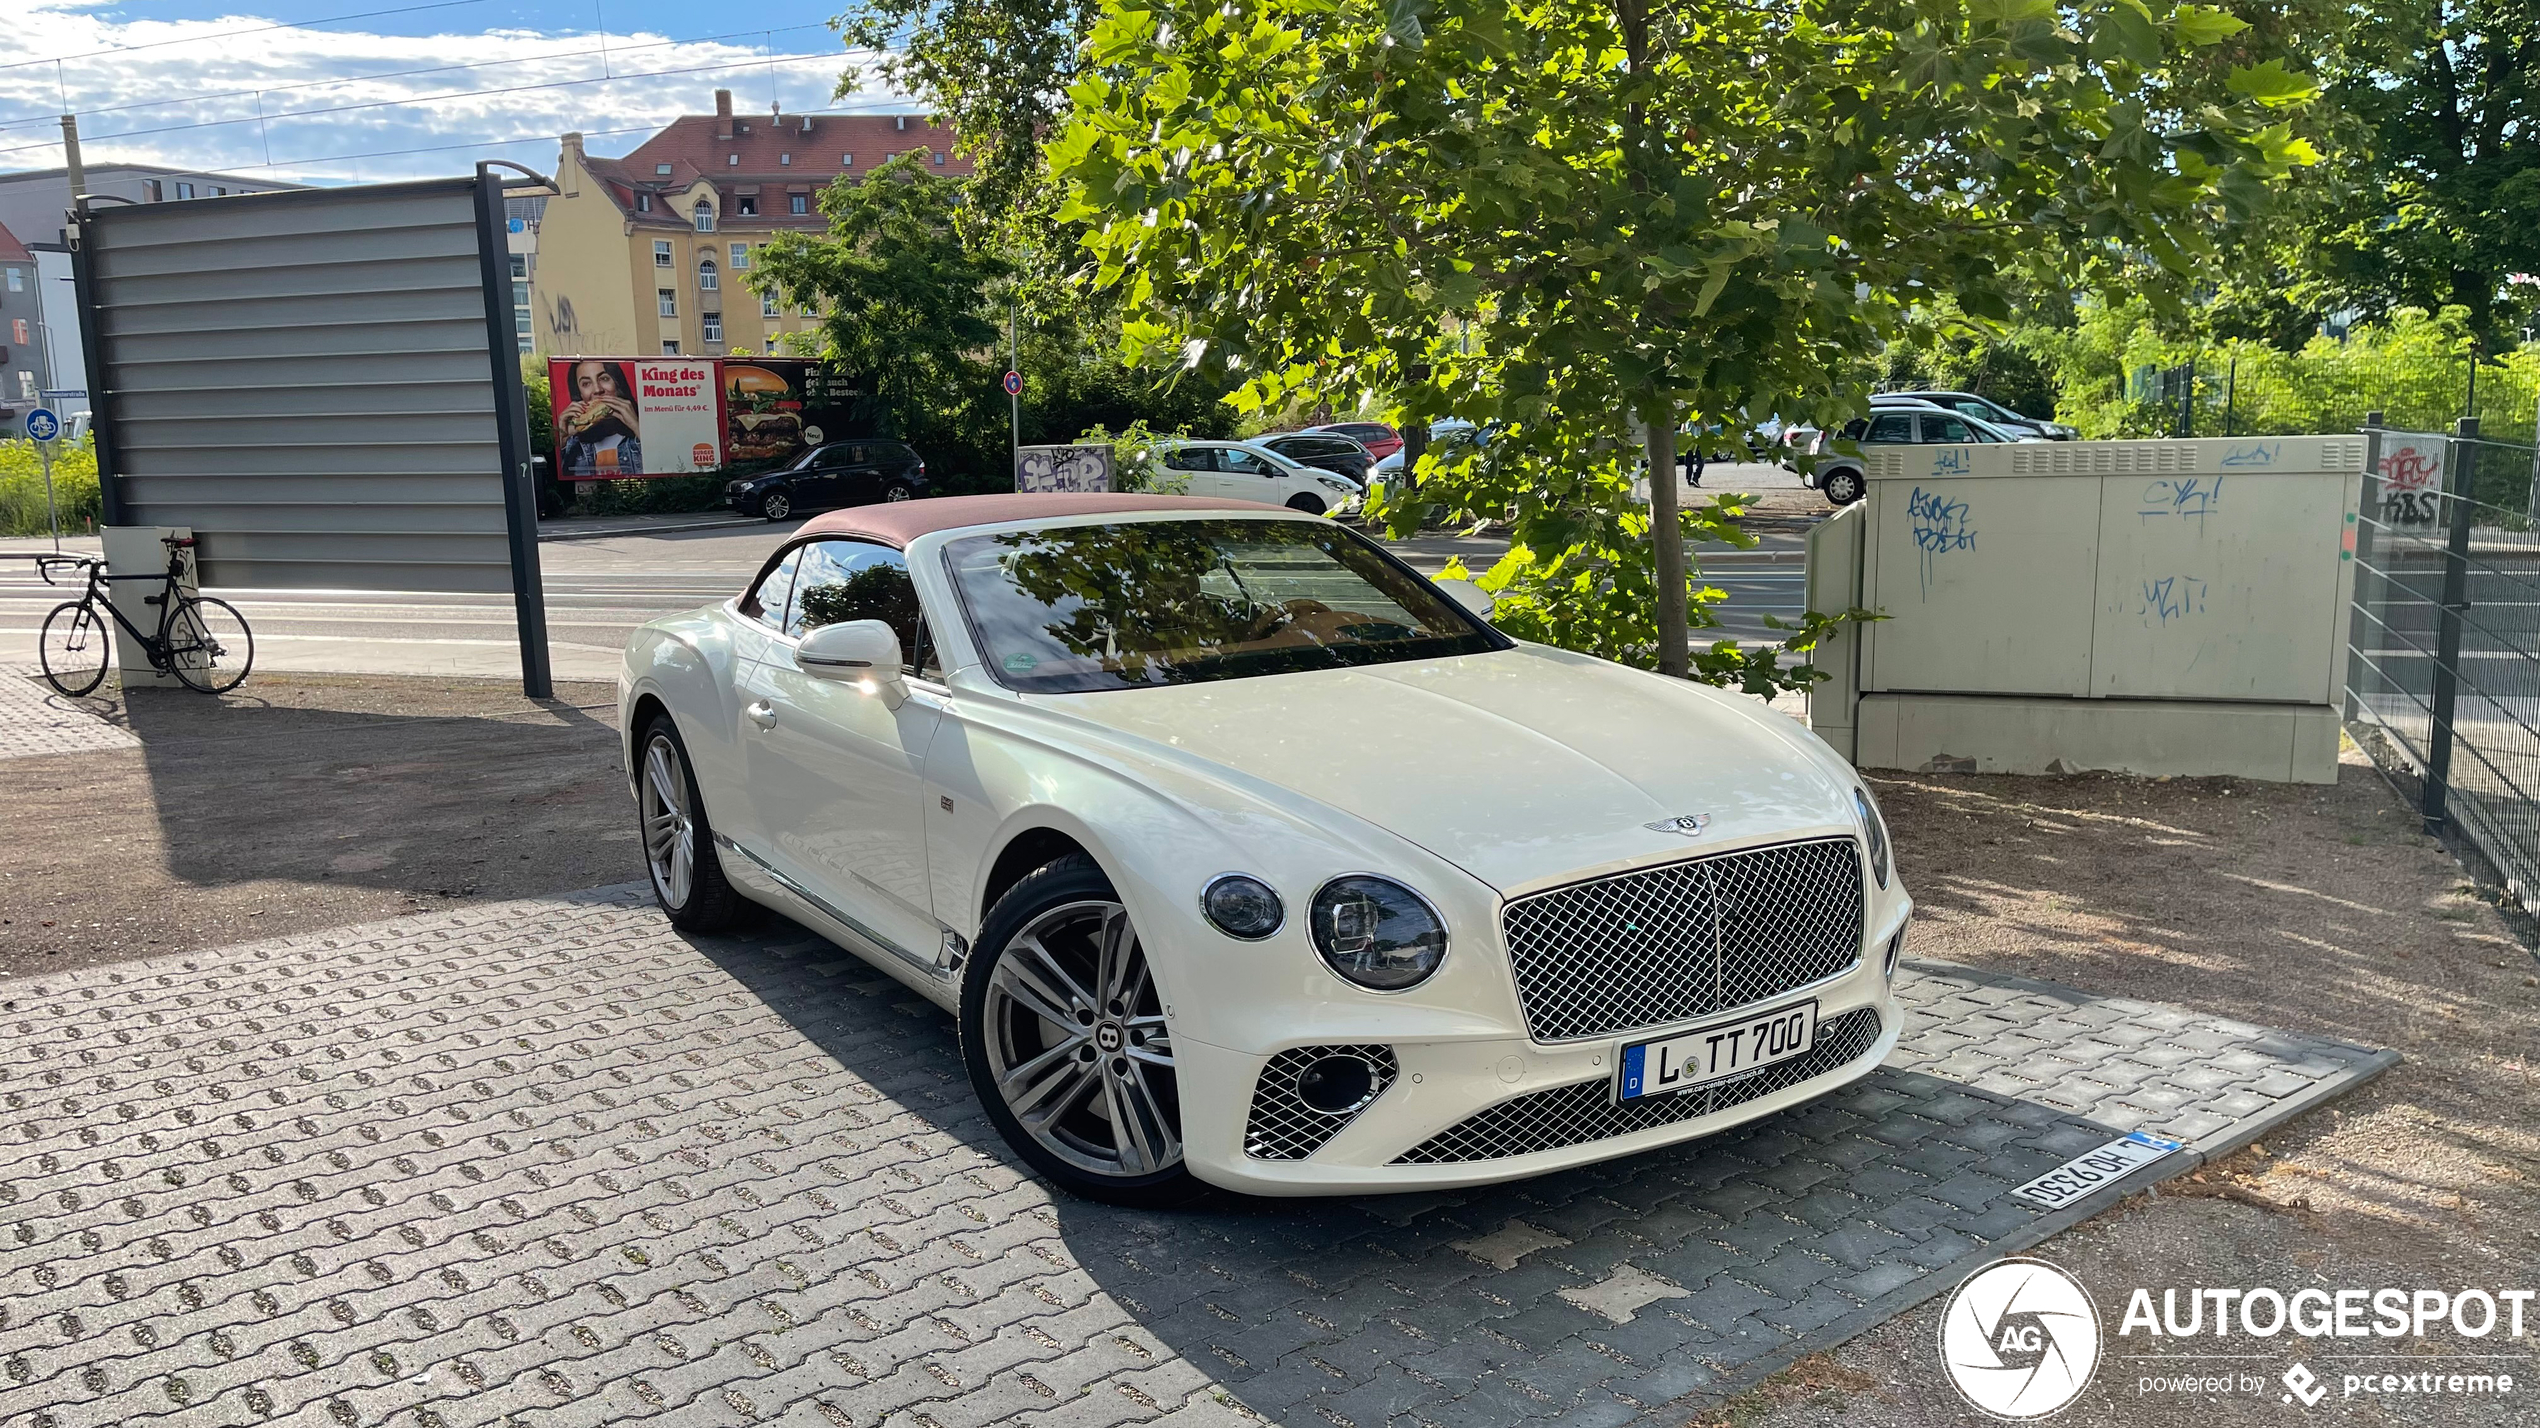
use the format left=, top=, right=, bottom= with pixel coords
left=0, top=516, right=1803, bottom=678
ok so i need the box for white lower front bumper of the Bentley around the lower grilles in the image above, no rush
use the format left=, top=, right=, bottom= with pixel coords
left=1173, top=943, right=1905, bottom=1194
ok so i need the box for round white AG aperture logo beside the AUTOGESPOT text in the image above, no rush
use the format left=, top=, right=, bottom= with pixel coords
left=1941, top=1258, right=2101, bottom=1423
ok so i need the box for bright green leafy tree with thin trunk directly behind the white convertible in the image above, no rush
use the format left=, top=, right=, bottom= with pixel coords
left=1049, top=0, right=2311, bottom=678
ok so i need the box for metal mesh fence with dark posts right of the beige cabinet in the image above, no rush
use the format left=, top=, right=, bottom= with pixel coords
left=2344, top=422, right=2540, bottom=910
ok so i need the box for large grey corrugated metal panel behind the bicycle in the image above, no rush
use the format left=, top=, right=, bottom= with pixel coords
left=84, top=178, right=516, bottom=589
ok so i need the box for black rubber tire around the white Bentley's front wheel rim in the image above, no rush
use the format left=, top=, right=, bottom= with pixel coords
left=960, top=854, right=1207, bottom=1209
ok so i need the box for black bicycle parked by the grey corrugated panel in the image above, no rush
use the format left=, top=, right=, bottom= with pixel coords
left=36, top=536, right=257, bottom=699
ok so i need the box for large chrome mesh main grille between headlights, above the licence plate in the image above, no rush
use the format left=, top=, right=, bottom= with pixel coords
left=1501, top=839, right=1862, bottom=1042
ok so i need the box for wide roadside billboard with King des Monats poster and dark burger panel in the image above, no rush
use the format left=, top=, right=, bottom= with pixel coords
left=546, top=358, right=853, bottom=480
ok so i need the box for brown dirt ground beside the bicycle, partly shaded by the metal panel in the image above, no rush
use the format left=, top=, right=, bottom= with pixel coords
left=0, top=673, right=640, bottom=976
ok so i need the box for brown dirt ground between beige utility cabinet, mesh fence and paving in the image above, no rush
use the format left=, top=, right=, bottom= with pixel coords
left=1699, top=765, right=2540, bottom=1428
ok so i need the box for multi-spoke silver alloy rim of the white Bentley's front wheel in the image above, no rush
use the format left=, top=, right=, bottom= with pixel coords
left=983, top=902, right=1181, bottom=1179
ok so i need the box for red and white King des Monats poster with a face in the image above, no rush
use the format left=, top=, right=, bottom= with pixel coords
left=546, top=358, right=724, bottom=480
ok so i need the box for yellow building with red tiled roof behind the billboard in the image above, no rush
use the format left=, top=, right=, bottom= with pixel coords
left=531, top=89, right=970, bottom=356
